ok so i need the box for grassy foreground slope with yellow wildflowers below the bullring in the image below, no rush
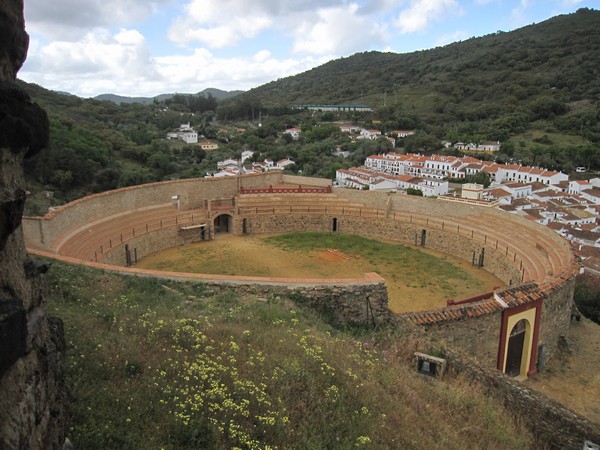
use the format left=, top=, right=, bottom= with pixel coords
left=48, top=263, right=532, bottom=449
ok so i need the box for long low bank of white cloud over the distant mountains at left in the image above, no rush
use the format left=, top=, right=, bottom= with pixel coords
left=19, top=29, right=332, bottom=97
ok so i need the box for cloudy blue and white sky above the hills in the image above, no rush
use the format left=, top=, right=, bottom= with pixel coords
left=19, top=0, right=599, bottom=97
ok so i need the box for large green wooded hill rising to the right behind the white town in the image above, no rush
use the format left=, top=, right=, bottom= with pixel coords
left=221, top=9, right=600, bottom=141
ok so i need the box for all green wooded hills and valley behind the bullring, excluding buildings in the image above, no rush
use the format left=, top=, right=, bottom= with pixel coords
left=18, top=9, right=600, bottom=213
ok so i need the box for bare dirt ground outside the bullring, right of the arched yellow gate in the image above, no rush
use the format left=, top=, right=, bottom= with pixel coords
left=526, top=319, right=600, bottom=426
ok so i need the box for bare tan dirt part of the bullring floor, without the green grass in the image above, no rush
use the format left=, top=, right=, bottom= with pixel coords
left=136, top=235, right=502, bottom=312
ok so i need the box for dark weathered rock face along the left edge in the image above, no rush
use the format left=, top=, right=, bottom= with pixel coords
left=0, top=0, right=67, bottom=449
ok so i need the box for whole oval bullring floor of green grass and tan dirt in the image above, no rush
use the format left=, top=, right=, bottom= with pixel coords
left=137, top=233, right=502, bottom=312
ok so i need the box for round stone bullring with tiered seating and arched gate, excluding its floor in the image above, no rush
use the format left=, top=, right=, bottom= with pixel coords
left=23, top=173, right=576, bottom=376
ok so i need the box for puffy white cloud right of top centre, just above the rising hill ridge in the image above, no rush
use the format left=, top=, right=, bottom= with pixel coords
left=293, top=3, right=386, bottom=55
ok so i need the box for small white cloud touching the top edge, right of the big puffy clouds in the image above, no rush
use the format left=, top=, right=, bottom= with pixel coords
left=395, top=0, right=462, bottom=33
